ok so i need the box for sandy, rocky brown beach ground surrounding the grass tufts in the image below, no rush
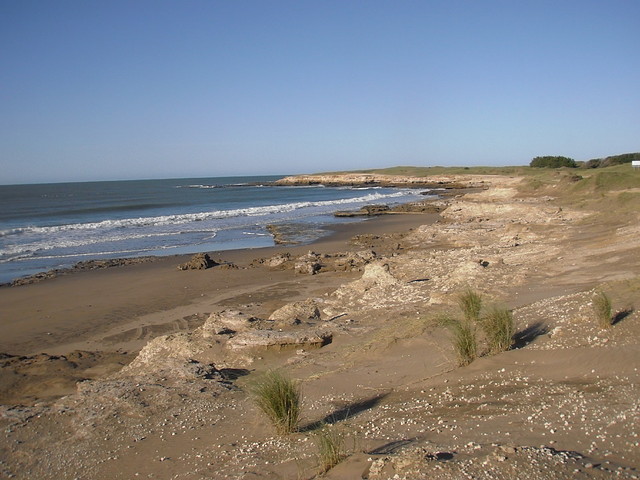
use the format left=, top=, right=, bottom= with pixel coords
left=0, top=177, right=640, bottom=480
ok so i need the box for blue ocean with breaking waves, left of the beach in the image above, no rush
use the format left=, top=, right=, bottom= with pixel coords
left=0, top=176, right=430, bottom=283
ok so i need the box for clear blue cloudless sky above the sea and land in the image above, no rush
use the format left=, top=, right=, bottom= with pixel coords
left=0, top=0, right=640, bottom=184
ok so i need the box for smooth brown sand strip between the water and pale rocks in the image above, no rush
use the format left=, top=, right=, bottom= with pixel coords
left=0, top=208, right=437, bottom=355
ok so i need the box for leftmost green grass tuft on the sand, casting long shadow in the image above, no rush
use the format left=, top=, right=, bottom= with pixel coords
left=251, top=371, right=302, bottom=435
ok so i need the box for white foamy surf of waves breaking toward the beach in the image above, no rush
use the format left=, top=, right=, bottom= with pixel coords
left=0, top=190, right=422, bottom=263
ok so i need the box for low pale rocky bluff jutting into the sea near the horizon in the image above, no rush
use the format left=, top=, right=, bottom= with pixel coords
left=274, top=173, right=494, bottom=189
